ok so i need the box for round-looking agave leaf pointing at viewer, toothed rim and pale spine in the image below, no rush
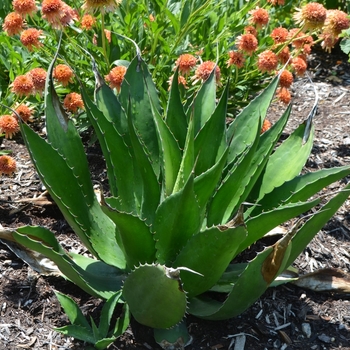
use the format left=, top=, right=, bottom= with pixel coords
left=123, top=265, right=187, bottom=328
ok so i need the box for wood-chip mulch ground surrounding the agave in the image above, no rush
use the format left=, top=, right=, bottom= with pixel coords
left=0, top=53, right=350, bottom=350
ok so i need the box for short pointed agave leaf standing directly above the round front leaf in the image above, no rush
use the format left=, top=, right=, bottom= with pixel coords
left=152, top=176, right=201, bottom=264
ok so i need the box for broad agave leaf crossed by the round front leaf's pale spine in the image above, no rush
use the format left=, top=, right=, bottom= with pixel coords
left=173, top=226, right=247, bottom=297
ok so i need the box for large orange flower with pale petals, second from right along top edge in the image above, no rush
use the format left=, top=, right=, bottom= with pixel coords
left=293, top=2, right=327, bottom=30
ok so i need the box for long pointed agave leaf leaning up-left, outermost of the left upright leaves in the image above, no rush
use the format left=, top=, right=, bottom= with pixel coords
left=21, top=124, right=126, bottom=269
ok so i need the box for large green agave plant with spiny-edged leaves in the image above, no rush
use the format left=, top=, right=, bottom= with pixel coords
left=2, top=45, right=350, bottom=349
